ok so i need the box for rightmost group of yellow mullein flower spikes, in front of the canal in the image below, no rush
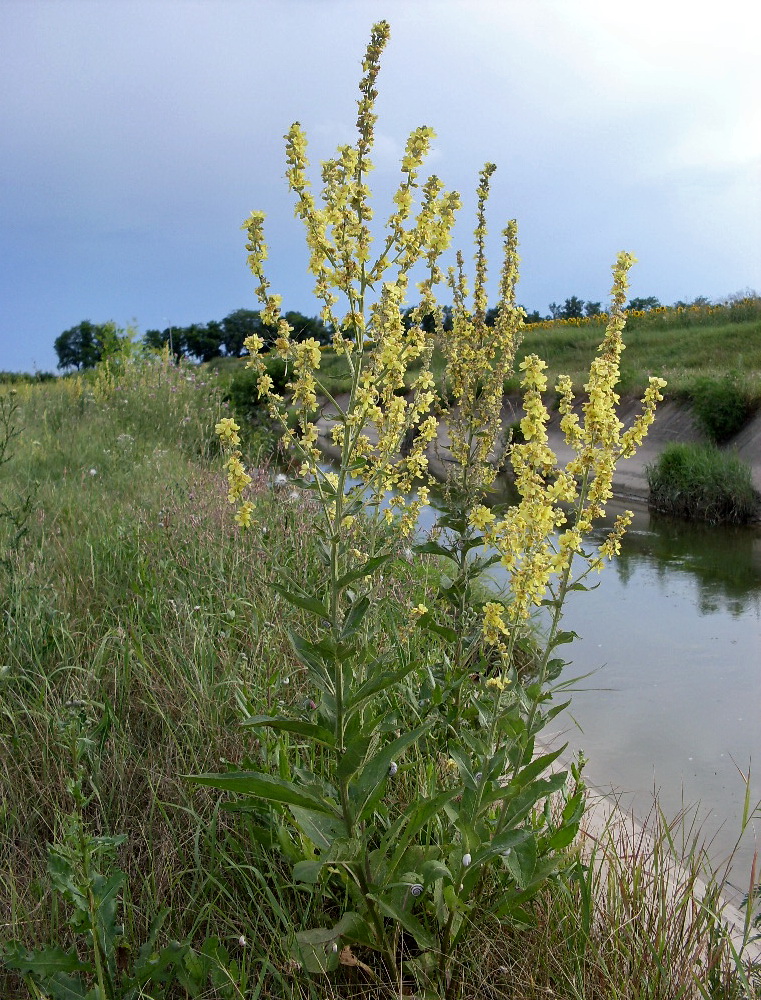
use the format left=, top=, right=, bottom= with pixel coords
left=480, top=253, right=665, bottom=622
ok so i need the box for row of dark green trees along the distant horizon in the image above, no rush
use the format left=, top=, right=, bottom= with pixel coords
left=53, top=295, right=672, bottom=370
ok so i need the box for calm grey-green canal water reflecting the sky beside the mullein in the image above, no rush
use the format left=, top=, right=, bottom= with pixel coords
left=326, top=464, right=761, bottom=895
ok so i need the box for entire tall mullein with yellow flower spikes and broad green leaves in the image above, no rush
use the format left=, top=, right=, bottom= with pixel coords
left=192, top=22, right=663, bottom=997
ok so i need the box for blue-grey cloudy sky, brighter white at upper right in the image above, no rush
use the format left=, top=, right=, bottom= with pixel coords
left=0, top=0, right=761, bottom=371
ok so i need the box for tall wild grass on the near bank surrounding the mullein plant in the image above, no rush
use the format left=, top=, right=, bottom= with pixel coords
left=0, top=363, right=752, bottom=1000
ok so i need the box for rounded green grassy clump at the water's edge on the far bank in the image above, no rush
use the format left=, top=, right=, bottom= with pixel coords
left=647, top=443, right=759, bottom=524
